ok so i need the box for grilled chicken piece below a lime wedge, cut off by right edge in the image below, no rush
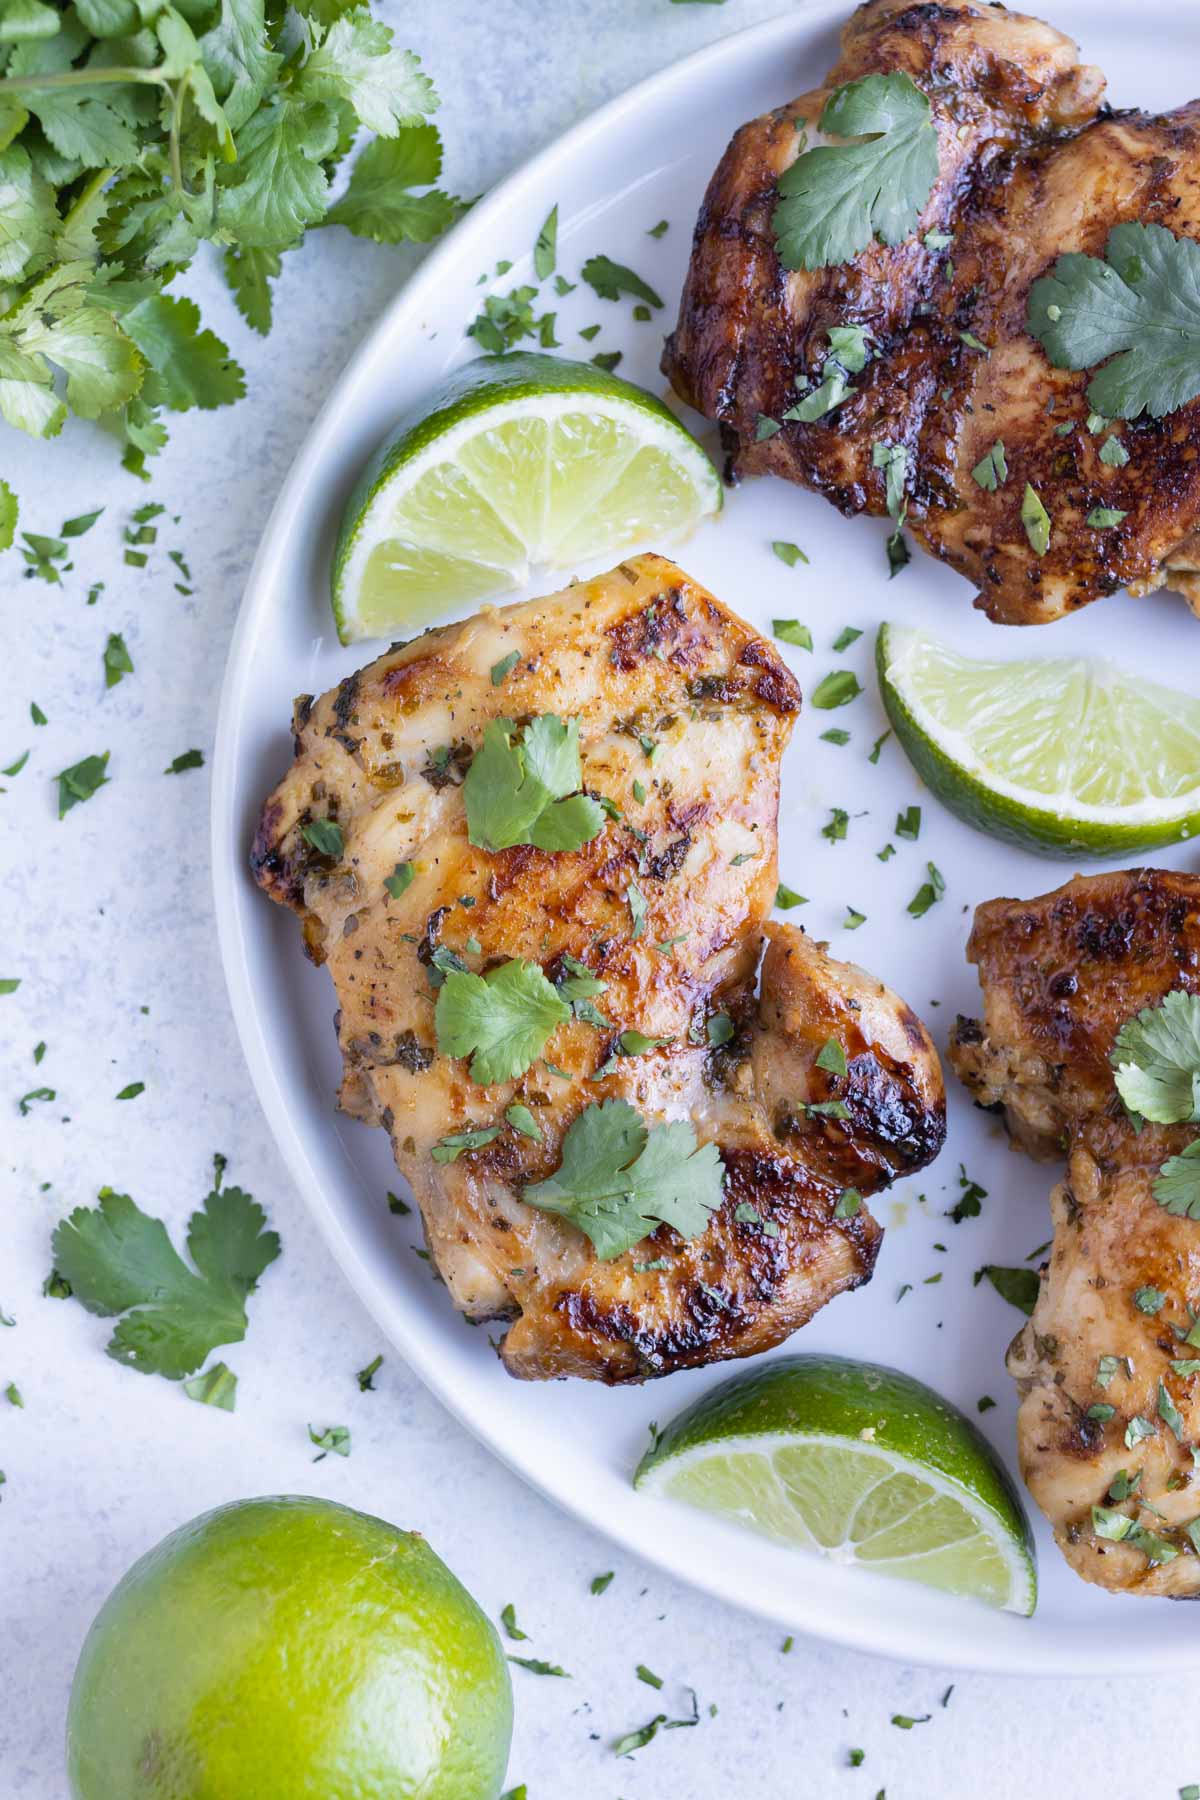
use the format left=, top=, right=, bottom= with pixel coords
left=950, top=869, right=1200, bottom=1597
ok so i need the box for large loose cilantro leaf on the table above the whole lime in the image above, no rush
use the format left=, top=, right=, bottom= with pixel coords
left=52, top=1165, right=279, bottom=1381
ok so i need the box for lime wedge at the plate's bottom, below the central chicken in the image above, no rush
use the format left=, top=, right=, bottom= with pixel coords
left=633, top=1355, right=1038, bottom=1616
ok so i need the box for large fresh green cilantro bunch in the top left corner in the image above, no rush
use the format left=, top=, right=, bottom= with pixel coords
left=0, top=0, right=461, bottom=475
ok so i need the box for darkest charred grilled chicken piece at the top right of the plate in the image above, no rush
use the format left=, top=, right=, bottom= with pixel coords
left=664, top=0, right=1200, bottom=625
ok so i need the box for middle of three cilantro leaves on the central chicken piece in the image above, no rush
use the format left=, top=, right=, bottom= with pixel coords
left=434, top=958, right=570, bottom=1087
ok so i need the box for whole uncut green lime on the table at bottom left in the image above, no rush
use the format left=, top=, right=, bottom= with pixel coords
left=67, top=1496, right=513, bottom=1800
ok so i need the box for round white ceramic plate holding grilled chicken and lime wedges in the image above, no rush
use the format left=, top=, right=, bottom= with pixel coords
left=212, top=0, right=1200, bottom=1674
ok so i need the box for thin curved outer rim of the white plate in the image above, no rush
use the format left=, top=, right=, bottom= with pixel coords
left=209, top=0, right=1200, bottom=1679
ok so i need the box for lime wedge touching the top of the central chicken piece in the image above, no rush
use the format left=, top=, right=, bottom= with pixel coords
left=333, top=353, right=721, bottom=643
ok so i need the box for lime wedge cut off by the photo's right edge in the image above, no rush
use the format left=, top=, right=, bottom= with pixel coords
left=876, top=625, right=1200, bottom=857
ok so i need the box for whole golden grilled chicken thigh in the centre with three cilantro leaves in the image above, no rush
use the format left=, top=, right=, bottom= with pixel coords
left=252, top=556, right=945, bottom=1382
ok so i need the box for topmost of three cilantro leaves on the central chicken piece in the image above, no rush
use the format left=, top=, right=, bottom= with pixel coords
left=462, top=713, right=604, bottom=851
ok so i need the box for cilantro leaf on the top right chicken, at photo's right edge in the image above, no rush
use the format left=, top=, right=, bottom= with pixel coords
left=1025, top=225, right=1200, bottom=419
